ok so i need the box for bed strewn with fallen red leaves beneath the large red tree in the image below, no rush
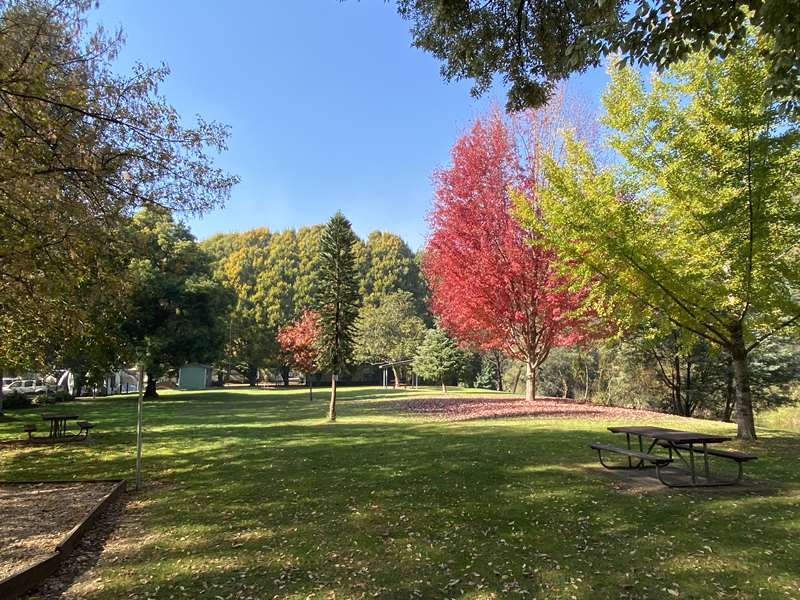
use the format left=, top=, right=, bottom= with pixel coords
left=395, top=396, right=661, bottom=421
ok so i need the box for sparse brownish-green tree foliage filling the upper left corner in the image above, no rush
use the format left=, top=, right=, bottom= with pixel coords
left=0, top=0, right=236, bottom=369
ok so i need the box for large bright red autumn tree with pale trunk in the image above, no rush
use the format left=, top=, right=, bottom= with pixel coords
left=423, top=107, right=590, bottom=400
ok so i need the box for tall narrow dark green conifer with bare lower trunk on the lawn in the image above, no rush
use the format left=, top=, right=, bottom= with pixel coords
left=317, top=212, right=359, bottom=421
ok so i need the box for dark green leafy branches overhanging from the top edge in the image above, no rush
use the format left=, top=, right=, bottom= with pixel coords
left=398, top=0, right=800, bottom=111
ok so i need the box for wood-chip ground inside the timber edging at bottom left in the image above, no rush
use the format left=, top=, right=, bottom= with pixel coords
left=0, top=481, right=117, bottom=580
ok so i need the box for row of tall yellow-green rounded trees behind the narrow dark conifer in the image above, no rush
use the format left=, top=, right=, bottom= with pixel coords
left=201, top=225, right=427, bottom=384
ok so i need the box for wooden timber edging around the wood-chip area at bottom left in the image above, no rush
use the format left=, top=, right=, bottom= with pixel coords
left=0, top=479, right=125, bottom=600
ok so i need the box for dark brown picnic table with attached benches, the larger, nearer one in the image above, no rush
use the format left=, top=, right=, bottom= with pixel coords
left=593, top=425, right=756, bottom=487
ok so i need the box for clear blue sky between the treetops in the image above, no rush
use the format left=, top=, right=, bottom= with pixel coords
left=91, top=0, right=605, bottom=249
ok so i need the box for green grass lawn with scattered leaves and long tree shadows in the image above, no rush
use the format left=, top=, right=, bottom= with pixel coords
left=0, top=388, right=800, bottom=599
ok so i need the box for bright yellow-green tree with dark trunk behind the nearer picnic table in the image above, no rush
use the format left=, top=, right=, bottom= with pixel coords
left=523, top=39, right=800, bottom=439
